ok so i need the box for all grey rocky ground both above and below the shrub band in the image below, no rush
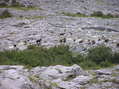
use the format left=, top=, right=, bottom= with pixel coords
left=0, top=0, right=119, bottom=89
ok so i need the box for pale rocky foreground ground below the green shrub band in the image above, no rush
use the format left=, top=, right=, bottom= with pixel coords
left=0, top=65, right=119, bottom=89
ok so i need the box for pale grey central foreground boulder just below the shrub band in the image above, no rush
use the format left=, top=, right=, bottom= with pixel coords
left=31, top=65, right=88, bottom=80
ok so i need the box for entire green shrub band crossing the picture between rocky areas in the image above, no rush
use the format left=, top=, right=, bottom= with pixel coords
left=0, top=45, right=119, bottom=69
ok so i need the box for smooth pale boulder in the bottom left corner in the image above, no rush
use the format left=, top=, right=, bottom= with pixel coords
left=0, top=66, right=35, bottom=89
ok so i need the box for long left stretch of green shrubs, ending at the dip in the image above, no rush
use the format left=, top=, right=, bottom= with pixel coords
left=0, top=46, right=72, bottom=67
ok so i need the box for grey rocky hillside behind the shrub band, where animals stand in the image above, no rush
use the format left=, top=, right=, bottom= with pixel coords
left=0, top=0, right=119, bottom=52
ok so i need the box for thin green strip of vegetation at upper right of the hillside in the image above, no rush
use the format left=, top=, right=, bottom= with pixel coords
left=62, top=11, right=119, bottom=19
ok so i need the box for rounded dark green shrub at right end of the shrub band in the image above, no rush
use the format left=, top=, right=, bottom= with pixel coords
left=87, top=45, right=112, bottom=64
